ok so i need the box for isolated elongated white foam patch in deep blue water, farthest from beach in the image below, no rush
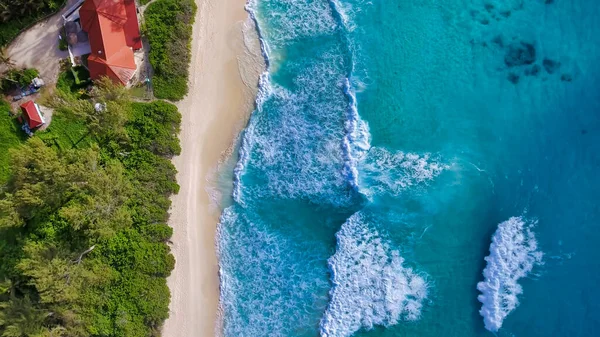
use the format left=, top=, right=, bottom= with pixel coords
left=477, top=217, right=543, bottom=332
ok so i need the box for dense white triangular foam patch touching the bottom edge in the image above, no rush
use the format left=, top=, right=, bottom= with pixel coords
left=321, top=213, right=427, bottom=337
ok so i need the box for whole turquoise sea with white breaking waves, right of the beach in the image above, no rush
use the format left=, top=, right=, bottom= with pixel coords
left=217, top=0, right=600, bottom=337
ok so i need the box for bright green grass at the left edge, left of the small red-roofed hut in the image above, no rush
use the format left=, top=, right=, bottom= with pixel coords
left=0, top=101, right=27, bottom=185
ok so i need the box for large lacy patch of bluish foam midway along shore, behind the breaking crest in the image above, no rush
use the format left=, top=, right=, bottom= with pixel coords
left=247, top=58, right=348, bottom=205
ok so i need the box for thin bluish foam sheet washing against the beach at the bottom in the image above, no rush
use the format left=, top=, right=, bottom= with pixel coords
left=217, top=205, right=329, bottom=337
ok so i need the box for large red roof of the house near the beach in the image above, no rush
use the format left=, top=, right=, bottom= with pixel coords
left=79, top=0, right=141, bottom=84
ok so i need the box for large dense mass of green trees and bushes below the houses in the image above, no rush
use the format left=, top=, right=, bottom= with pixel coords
left=0, top=79, right=181, bottom=337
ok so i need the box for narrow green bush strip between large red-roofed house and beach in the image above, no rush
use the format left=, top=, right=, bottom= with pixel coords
left=144, top=0, right=196, bottom=101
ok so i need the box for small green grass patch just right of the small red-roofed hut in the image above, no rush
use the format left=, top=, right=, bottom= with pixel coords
left=35, top=115, right=95, bottom=150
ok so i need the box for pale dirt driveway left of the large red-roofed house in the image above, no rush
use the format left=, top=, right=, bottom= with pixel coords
left=8, top=0, right=77, bottom=83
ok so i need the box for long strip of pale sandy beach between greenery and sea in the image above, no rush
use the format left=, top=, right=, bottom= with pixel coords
left=163, top=0, right=262, bottom=337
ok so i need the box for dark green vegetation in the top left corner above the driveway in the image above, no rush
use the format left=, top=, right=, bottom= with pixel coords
left=0, top=0, right=66, bottom=47
